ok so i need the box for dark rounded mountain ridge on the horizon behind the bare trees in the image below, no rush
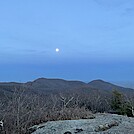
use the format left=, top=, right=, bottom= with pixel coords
left=0, top=78, right=134, bottom=95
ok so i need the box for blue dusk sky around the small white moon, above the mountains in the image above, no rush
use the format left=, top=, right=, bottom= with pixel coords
left=0, top=0, right=134, bottom=82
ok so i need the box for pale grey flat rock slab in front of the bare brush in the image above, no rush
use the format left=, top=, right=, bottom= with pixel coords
left=31, top=114, right=134, bottom=134
